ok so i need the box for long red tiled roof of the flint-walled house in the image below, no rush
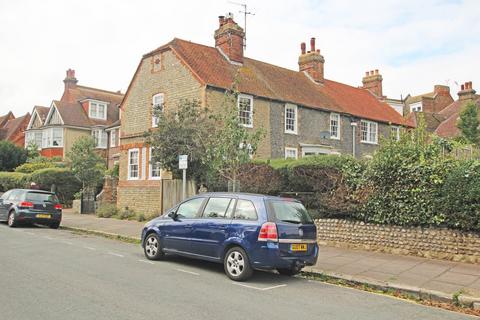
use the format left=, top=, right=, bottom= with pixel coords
left=144, top=38, right=406, bottom=125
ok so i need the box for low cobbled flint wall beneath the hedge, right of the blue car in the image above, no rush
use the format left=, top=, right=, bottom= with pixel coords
left=315, top=219, right=480, bottom=263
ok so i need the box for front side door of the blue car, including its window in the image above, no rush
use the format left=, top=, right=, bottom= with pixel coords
left=162, top=197, right=206, bottom=252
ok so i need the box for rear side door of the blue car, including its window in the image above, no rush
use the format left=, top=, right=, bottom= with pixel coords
left=191, top=197, right=235, bottom=258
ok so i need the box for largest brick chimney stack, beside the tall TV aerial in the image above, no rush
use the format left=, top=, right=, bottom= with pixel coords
left=215, top=13, right=245, bottom=63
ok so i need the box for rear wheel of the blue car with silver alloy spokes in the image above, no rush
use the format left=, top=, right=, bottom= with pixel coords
left=223, top=247, right=253, bottom=281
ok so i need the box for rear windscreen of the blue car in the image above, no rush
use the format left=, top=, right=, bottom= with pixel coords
left=267, top=200, right=313, bottom=224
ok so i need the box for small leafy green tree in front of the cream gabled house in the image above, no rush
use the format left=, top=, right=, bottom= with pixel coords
left=67, top=137, right=106, bottom=193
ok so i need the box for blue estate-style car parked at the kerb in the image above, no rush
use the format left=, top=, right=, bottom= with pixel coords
left=142, top=193, right=318, bottom=281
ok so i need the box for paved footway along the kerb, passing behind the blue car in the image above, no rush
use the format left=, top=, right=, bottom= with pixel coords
left=62, top=210, right=480, bottom=304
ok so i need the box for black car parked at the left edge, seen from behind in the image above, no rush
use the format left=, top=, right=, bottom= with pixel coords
left=0, top=189, right=62, bottom=229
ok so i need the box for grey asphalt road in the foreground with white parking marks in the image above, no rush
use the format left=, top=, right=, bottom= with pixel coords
left=0, top=224, right=472, bottom=320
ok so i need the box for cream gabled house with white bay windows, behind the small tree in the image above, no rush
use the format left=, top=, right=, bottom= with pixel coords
left=25, top=69, right=123, bottom=165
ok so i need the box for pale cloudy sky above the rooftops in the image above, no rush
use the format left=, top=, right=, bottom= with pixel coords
left=0, top=0, right=480, bottom=116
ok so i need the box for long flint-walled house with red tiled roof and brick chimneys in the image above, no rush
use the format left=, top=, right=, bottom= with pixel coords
left=118, top=15, right=404, bottom=211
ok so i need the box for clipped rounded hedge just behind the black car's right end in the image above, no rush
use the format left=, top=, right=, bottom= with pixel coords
left=30, top=168, right=81, bottom=206
